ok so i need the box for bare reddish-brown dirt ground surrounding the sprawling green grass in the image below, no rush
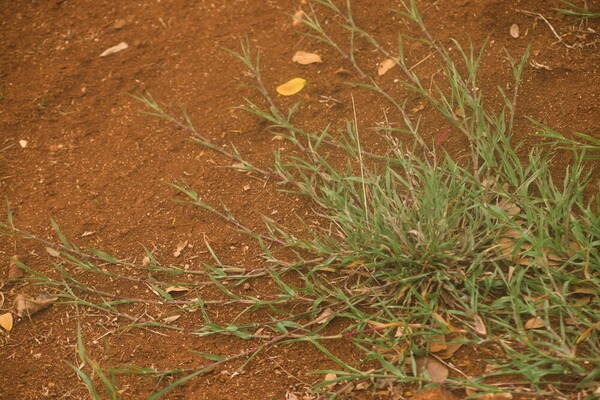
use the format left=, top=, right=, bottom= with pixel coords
left=0, top=0, right=600, bottom=400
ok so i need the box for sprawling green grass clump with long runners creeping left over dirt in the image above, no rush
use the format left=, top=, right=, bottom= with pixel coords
left=2, top=0, right=600, bottom=399
